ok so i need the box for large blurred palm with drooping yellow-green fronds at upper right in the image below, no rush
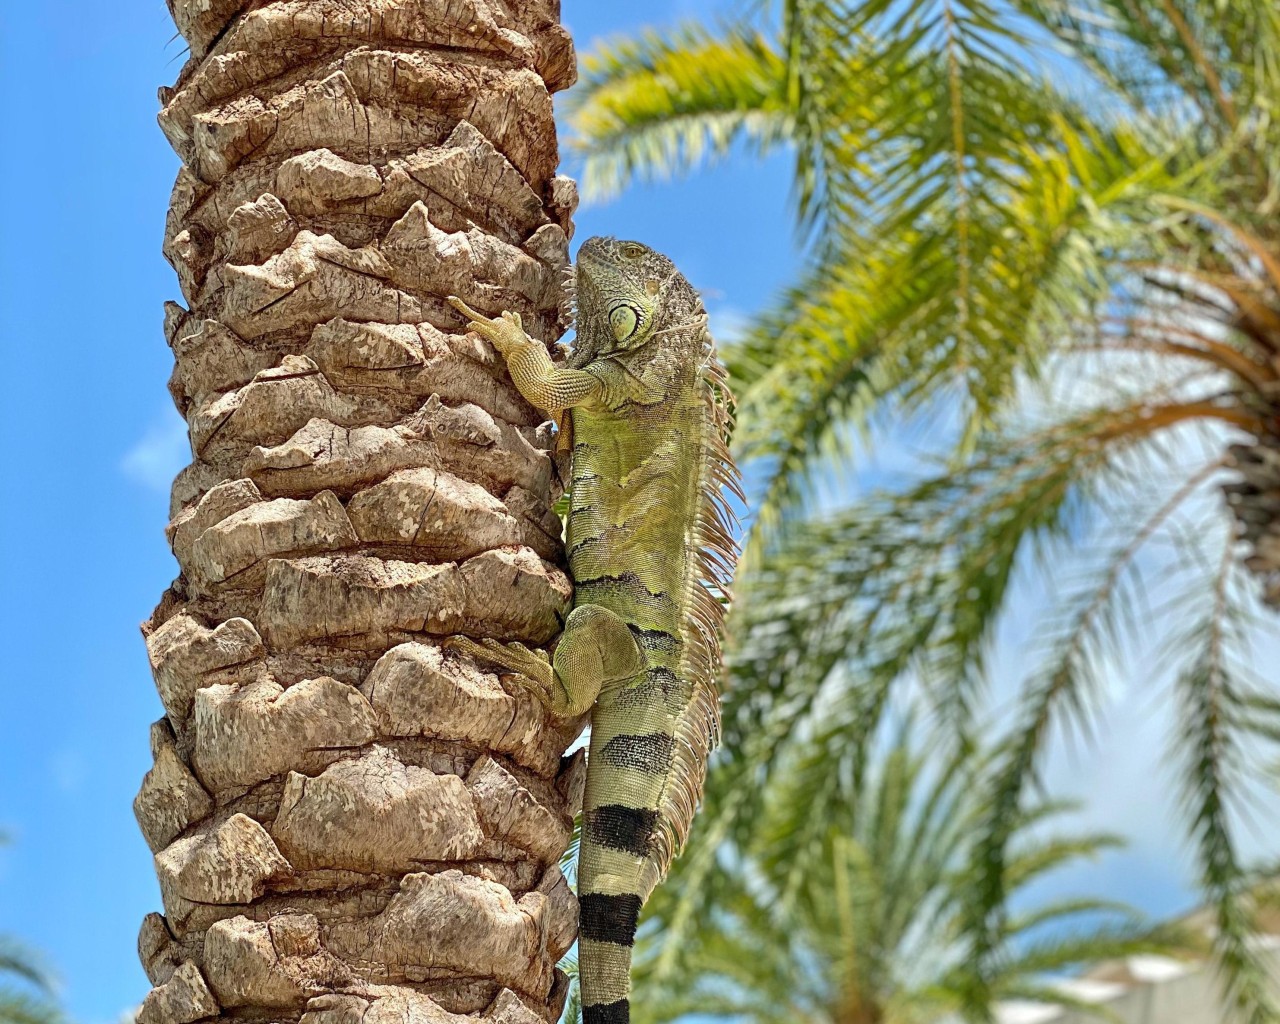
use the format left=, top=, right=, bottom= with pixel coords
left=573, top=0, right=1280, bottom=1020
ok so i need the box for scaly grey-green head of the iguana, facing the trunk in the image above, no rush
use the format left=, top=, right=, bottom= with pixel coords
left=575, top=237, right=700, bottom=357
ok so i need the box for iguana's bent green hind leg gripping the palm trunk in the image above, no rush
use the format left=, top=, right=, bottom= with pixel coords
left=445, top=604, right=645, bottom=718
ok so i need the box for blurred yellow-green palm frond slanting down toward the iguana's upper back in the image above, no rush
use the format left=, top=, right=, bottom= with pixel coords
left=728, top=111, right=1198, bottom=542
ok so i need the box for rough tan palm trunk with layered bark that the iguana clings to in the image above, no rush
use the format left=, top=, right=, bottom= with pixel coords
left=136, top=0, right=581, bottom=1024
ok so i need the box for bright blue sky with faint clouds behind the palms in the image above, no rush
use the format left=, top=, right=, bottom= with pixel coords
left=0, top=0, right=1274, bottom=1024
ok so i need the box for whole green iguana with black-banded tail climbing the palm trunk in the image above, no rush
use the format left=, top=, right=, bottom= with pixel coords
left=451, top=238, right=741, bottom=1024
